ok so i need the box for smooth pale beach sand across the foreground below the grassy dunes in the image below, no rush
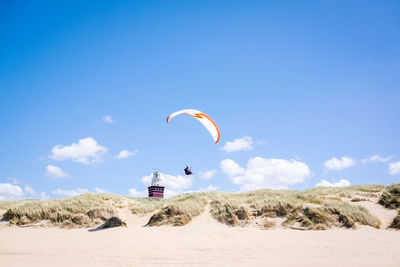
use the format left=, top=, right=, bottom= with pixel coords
left=0, top=207, right=400, bottom=267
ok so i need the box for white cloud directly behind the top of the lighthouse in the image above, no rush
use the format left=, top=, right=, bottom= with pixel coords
left=139, top=173, right=192, bottom=197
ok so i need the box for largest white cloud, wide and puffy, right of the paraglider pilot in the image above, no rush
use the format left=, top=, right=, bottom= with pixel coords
left=221, top=157, right=311, bottom=191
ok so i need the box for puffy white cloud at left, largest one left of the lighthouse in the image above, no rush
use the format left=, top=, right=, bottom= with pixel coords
left=49, top=137, right=107, bottom=165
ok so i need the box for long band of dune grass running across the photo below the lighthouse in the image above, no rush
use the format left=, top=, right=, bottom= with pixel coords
left=0, top=185, right=388, bottom=229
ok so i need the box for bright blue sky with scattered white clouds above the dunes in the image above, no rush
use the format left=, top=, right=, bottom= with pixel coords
left=0, top=1, right=400, bottom=199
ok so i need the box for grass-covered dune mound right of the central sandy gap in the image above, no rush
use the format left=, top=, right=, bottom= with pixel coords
left=211, top=190, right=380, bottom=230
